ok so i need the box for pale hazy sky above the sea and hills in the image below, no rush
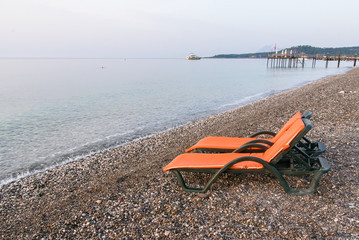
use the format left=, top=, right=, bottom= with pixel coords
left=0, top=0, right=359, bottom=58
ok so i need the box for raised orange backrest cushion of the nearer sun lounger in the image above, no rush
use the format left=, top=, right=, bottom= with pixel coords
left=263, top=118, right=305, bottom=162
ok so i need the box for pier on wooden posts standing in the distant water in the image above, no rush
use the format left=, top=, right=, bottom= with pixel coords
left=267, top=51, right=359, bottom=68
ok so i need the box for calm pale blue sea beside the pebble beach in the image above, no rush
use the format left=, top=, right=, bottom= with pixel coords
left=0, top=59, right=352, bottom=184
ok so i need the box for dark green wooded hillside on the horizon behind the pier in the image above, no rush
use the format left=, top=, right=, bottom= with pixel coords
left=210, top=45, right=359, bottom=58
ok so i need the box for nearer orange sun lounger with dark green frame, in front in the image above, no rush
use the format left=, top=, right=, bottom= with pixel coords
left=163, top=118, right=330, bottom=195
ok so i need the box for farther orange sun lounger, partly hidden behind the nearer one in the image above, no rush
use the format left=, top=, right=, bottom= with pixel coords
left=186, top=111, right=325, bottom=156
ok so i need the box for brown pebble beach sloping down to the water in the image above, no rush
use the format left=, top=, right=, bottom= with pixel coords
left=0, top=68, right=359, bottom=239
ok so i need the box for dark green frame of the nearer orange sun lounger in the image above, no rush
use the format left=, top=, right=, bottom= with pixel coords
left=170, top=119, right=330, bottom=195
